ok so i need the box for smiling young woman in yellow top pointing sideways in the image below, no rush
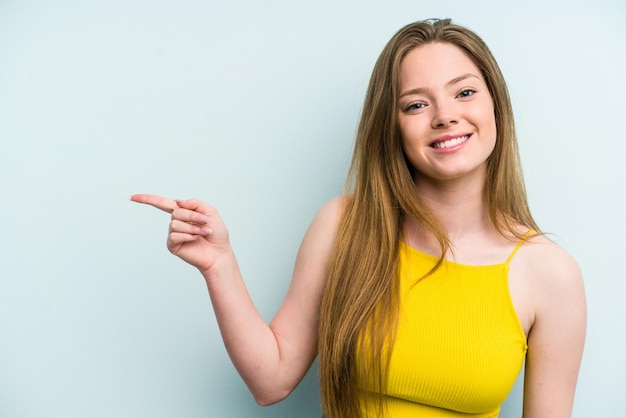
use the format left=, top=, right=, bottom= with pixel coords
left=131, top=20, right=586, bottom=418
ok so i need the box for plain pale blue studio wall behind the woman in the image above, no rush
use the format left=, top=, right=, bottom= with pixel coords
left=0, top=0, right=626, bottom=418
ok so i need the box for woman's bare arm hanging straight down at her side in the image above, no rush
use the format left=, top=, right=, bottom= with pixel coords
left=523, top=243, right=587, bottom=418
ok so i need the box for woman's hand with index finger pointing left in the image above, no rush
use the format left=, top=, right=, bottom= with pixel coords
left=130, top=194, right=231, bottom=277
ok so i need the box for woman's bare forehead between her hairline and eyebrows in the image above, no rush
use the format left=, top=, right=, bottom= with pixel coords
left=400, top=43, right=484, bottom=88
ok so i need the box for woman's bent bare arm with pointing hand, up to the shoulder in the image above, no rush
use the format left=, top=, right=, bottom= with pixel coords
left=131, top=195, right=343, bottom=405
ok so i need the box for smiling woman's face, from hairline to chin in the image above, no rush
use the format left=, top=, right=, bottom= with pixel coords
left=398, top=43, right=496, bottom=181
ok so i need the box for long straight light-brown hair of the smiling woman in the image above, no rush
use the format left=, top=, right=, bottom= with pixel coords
left=319, top=19, right=539, bottom=418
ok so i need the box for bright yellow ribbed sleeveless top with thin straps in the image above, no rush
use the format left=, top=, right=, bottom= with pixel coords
left=357, top=241, right=528, bottom=418
